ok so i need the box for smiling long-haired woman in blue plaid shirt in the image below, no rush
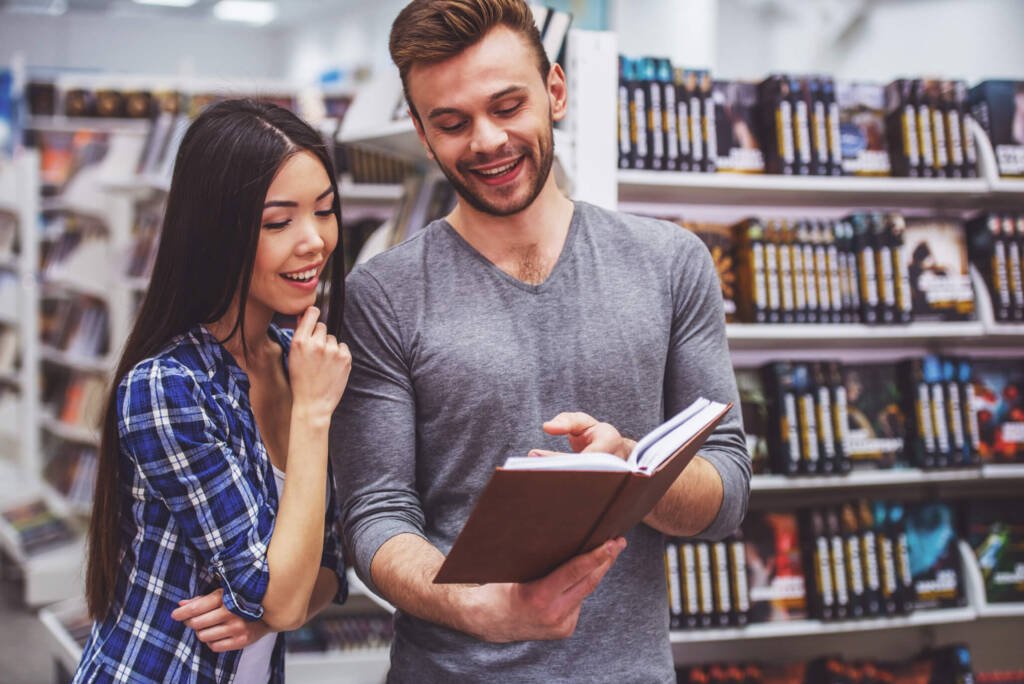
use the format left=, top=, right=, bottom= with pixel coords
left=75, top=100, right=350, bottom=684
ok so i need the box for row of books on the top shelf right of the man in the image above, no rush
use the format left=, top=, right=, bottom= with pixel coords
left=617, top=55, right=1024, bottom=178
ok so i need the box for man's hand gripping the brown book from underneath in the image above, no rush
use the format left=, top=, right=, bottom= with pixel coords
left=464, top=537, right=626, bottom=643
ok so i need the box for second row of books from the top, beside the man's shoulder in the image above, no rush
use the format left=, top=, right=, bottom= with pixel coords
left=672, top=211, right=978, bottom=325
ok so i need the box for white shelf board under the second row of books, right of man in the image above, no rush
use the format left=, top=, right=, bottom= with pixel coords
left=726, top=320, right=985, bottom=349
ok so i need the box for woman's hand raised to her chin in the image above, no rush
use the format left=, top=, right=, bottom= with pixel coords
left=288, top=306, right=352, bottom=421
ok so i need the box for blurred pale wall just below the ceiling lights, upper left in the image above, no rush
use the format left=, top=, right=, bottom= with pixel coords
left=0, top=13, right=288, bottom=82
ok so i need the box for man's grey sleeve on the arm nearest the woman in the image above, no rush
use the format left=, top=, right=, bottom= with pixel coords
left=331, top=268, right=426, bottom=594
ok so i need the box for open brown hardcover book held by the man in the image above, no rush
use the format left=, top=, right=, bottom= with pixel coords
left=434, top=398, right=732, bottom=584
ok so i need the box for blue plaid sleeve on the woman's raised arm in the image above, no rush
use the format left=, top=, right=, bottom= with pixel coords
left=118, top=361, right=274, bottom=621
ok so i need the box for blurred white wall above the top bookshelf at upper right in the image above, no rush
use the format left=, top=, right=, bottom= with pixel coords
left=610, top=0, right=1024, bottom=83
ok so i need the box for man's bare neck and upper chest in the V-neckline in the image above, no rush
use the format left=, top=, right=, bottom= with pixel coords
left=447, top=177, right=573, bottom=285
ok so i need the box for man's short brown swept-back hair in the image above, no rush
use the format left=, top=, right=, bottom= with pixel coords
left=388, top=0, right=551, bottom=118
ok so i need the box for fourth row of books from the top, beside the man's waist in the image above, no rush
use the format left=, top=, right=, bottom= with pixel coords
left=688, top=501, right=974, bottom=629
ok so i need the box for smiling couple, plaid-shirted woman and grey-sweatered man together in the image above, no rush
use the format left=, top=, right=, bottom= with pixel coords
left=70, top=0, right=750, bottom=682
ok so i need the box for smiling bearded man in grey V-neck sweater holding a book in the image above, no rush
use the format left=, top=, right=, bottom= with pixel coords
left=332, top=0, right=750, bottom=682
